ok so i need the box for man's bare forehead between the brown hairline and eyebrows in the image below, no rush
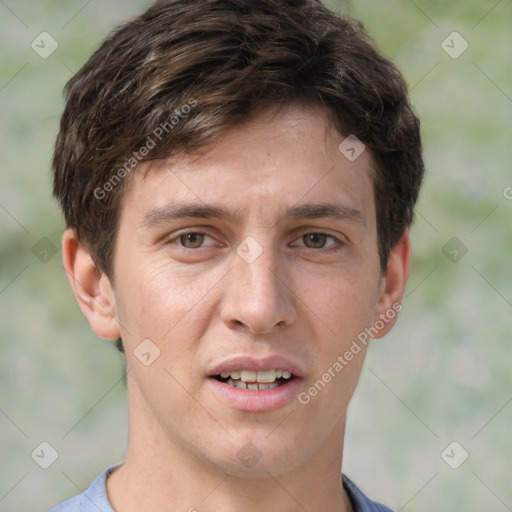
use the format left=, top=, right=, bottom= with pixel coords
left=123, top=106, right=373, bottom=224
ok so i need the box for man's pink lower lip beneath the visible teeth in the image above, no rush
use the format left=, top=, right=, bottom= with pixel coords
left=208, top=377, right=302, bottom=412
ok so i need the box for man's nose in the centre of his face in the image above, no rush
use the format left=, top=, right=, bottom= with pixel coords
left=221, top=241, right=297, bottom=334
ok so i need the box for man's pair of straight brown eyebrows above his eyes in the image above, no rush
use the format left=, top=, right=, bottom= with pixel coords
left=141, top=203, right=366, bottom=228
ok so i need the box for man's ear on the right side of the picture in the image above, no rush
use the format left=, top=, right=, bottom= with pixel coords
left=373, top=230, right=411, bottom=338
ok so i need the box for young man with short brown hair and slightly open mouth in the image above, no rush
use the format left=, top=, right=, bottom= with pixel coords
left=52, top=0, right=423, bottom=512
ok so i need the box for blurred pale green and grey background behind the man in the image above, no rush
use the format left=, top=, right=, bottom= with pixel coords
left=0, top=0, right=512, bottom=512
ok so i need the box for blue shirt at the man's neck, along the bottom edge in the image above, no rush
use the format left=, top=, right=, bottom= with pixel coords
left=48, top=464, right=391, bottom=512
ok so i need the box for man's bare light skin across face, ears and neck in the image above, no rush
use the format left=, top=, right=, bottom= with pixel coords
left=63, top=106, right=410, bottom=512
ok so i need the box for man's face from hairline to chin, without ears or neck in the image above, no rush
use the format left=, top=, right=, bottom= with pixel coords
left=71, top=107, right=405, bottom=475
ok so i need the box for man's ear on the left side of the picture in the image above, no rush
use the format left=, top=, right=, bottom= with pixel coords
left=62, top=229, right=121, bottom=339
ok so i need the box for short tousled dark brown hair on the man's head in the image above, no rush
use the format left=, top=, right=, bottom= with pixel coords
left=53, top=0, right=424, bottom=277
